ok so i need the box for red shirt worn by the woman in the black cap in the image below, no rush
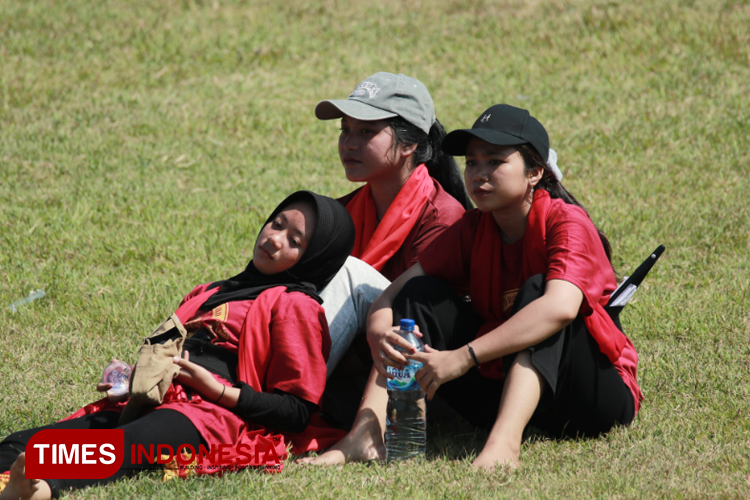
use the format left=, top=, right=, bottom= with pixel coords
left=419, top=199, right=641, bottom=411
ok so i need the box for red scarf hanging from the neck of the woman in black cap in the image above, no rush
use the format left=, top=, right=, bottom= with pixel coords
left=469, top=189, right=626, bottom=379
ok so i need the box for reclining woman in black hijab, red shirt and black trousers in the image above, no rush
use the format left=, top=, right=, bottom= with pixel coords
left=0, top=191, right=354, bottom=499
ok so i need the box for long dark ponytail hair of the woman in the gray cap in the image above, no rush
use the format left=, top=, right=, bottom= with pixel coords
left=386, top=116, right=474, bottom=210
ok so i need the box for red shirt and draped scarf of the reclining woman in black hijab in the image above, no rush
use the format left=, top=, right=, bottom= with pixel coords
left=63, top=285, right=344, bottom=462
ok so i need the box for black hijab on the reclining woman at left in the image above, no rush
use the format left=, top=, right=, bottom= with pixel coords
left=201, top=191, right=354, bottom=311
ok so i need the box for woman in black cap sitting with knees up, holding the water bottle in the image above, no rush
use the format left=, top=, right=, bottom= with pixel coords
left=312, top=105, right=642, bottom=469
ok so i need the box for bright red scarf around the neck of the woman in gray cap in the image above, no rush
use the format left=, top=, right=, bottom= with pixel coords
left=346, top=164, right=435, bottom=271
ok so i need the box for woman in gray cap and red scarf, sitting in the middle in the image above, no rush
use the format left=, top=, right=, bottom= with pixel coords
left=315, top=72, right=471, bottom=372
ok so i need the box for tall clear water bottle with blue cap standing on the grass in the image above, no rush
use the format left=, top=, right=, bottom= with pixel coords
left=385, top=319, right=427, bottom=462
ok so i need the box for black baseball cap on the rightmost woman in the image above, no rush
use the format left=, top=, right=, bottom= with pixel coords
left=440, top=104, right=549, bottom=162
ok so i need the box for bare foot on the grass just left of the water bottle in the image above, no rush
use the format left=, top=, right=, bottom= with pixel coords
left=297, top=412, right=385, bottom=465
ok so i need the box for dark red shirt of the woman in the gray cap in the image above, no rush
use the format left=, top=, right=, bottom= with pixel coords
left=338, top=179, right=465, bottom=281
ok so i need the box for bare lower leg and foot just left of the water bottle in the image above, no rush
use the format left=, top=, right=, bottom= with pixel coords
left=297, top=368, right=388, bottom=465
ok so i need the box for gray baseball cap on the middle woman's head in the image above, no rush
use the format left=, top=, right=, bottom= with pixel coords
left=315, top=72, right=435, bottom=134
